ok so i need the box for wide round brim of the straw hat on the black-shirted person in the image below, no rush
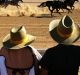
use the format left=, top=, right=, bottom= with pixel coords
left=49, top=19, right=80, bottom=44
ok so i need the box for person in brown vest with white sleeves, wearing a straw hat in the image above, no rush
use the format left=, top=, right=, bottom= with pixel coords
left=0, top=26, right=42, bottom=75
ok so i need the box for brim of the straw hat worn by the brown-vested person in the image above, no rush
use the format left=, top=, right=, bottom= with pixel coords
left=3, top=34, right=35, bottom=49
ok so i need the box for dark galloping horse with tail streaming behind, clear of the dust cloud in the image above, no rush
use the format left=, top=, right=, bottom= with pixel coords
left=38, top=1, right=71, bottom=16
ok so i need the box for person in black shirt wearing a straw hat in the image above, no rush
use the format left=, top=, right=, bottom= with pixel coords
left=39, top=15, right=80, bottom=75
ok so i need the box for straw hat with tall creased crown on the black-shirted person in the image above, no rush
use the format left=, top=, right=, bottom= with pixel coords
left=49, top=15, right=80, bottom=44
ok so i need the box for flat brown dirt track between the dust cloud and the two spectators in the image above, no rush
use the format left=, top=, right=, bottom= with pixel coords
left=0, top=9, right=80, bottom=49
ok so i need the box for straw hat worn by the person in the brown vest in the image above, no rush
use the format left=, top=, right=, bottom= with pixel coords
left=3, top=26, right=35, bottom=49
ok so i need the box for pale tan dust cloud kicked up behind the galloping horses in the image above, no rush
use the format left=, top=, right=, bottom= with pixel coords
left=0, top=3, right=49, bottom=16
